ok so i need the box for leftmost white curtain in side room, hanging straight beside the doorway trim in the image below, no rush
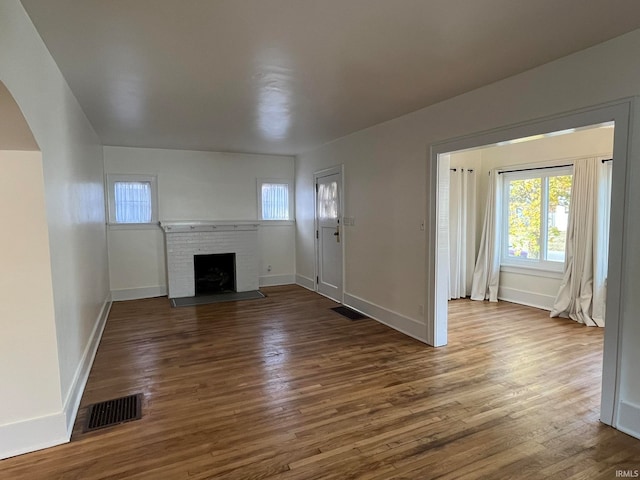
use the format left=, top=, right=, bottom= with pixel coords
left=449, top=168, right=476, bottom=300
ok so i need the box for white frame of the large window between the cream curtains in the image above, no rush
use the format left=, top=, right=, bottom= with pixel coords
left=499, top=165, right=573, bottom=272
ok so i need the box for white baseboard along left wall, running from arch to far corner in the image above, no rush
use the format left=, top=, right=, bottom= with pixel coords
left=62, top=296, right=113, bottom=438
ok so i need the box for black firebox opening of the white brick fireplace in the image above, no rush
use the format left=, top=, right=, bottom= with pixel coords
left=193, top=253, right=236, bottom=296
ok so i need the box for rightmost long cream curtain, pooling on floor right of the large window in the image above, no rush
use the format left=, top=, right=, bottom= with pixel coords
left=551, top=158, right=611, bottom=327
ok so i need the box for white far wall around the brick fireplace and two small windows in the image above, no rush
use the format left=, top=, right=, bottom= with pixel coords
left=104, top=147, right=295, bottom=299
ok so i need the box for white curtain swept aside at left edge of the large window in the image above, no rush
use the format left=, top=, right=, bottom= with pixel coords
left=471, top=170, right=502, bottom=302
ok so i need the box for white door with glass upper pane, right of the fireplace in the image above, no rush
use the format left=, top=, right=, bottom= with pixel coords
left=315, top=167, right=342, bottom=302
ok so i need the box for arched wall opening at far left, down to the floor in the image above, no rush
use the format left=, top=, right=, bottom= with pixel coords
left=0, top=82, right=67, bottom=458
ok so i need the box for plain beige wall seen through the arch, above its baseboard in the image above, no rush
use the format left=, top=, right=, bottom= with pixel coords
left=0, top=151, right=62, bottom=442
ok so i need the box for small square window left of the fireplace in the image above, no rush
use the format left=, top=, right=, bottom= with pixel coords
left=107, top=175, right=158, bottom=225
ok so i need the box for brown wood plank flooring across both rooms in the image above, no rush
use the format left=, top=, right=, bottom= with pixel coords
left=0, top=286, right=640, bottom=480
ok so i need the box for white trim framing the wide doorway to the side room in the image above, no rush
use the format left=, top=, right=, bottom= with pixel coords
left=425, top=98, right=634, bottom=427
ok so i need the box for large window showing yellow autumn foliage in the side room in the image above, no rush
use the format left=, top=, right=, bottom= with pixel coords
left=502, top=167, right=573, bottom=270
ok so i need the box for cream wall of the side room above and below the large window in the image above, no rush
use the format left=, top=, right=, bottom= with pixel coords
left=462, top=128, right=614, bottom=310
